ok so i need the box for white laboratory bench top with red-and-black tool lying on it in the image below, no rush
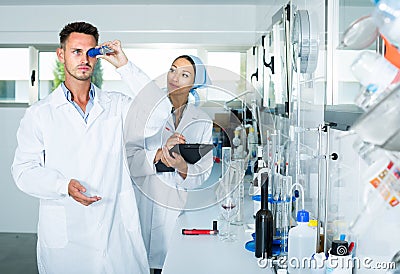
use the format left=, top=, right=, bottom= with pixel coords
left=163, top=182, right=275, bottom=274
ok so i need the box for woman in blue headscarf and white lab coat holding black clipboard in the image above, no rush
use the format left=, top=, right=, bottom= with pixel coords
left=127, top=55, right=213, bottom=273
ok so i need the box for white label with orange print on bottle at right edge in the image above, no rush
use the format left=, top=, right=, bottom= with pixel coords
left=370, top=161, right=400, bottom=207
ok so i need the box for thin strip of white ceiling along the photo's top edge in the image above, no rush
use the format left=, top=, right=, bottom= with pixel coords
left=0, top=0, right=268, bottom=6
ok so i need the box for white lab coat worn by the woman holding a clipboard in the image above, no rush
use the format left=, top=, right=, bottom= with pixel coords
left=127, top=99, right=213, bottom=268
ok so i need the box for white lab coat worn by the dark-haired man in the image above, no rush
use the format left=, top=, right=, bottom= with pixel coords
left=12, top=63, right=170, bottom=274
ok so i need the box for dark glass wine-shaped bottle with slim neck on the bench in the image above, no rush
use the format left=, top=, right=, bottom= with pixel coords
left=255, top=172, right=274, bottom=258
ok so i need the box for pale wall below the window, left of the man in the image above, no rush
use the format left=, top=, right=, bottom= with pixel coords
left=0, top=107, right=39, bottom=232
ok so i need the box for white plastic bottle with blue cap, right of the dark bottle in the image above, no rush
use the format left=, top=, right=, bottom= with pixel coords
left=287, top=210, right=317, bottom=274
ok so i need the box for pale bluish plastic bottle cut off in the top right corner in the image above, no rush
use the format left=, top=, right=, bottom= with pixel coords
left=372, top=0, right=400, bottom=47
